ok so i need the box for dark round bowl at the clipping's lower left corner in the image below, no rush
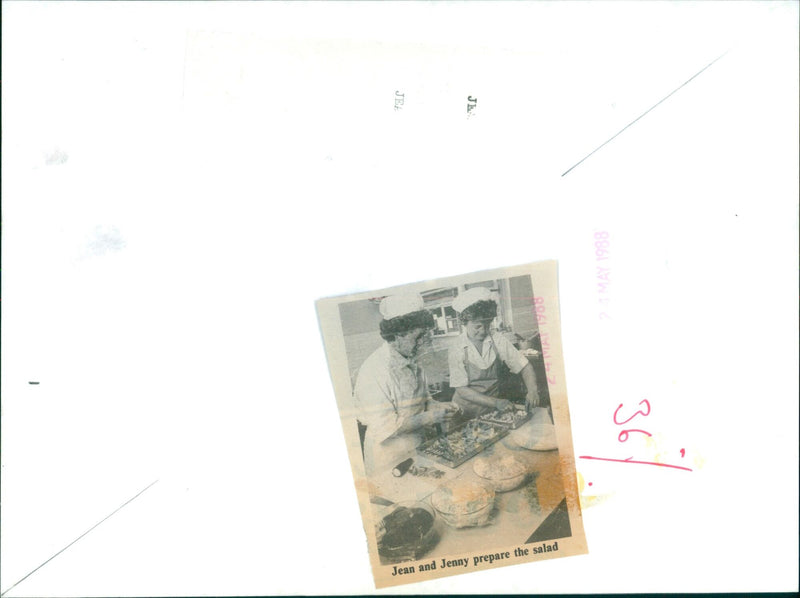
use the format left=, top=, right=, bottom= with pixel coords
left=375, top=501, right=440, bottom=563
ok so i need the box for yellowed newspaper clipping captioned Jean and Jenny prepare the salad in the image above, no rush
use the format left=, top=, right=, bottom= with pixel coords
left=317, top=261, right=587, bottom=588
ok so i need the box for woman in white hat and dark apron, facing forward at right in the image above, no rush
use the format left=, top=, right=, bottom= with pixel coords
left=448, top=287, right=539, bottom=417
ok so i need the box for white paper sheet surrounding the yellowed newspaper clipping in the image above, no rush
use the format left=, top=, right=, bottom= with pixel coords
left=0, top=2, right=798, bottom=596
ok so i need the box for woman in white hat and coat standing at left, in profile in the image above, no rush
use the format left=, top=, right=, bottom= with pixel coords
left=353, top=293, right=459, bottom=475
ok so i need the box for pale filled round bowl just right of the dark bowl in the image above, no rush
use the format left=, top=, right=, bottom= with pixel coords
left=431, top=480, right=495, bottom=528
